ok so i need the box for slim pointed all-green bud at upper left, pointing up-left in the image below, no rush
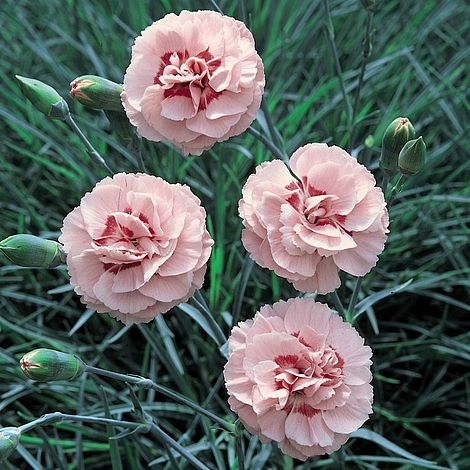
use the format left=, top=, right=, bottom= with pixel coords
left=16, top=75, right=70, bottom=120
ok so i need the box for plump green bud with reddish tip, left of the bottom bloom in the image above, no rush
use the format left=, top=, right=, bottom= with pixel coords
left=20, top=348, right=86, bottom=382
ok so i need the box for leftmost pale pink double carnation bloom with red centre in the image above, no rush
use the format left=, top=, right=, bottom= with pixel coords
left=59, top=173, right=213, bottom=323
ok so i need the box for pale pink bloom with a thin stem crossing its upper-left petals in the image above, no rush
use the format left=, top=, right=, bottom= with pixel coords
left=239, top=144, right=388, bottom=294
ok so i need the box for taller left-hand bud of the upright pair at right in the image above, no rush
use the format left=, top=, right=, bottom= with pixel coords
left=380, top=118, right=415, bottom=172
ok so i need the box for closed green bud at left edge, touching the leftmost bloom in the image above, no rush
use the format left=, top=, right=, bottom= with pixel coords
left=0, top=234, right=65, bottom=268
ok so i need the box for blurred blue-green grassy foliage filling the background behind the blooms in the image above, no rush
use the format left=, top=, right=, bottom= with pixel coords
left=0, top=0, right=470, bottom=470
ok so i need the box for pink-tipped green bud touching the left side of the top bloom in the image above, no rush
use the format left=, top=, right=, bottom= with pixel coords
left=70, top=75, right=124, bottom=112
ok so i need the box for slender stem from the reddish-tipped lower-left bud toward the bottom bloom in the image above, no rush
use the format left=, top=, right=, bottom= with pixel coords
left=86, top=365, right=236, bottom=432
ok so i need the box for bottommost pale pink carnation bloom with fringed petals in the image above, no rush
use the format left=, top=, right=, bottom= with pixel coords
left=224, top=298, right=373, bottom=460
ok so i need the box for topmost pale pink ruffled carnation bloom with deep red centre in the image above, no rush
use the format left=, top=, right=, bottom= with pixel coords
left=122, top=11, right=264, bottom=155
